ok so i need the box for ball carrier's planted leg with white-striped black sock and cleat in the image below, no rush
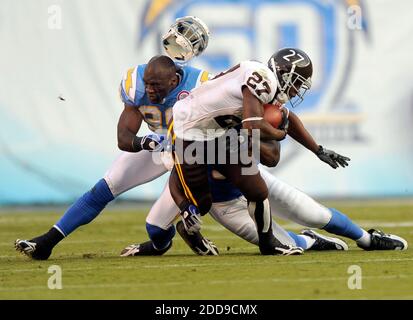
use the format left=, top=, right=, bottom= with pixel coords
left=219, top=163, right=302, bottom=255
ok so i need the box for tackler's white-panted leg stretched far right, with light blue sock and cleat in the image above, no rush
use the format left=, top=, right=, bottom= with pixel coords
left=260, top=167, right=407, bottom=250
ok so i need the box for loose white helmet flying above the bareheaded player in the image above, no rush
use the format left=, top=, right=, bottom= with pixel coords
left=162, top=16, right=210, bottom=61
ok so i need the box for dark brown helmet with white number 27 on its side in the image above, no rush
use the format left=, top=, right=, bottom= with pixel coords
left=268, top=48, right=313, bottom=108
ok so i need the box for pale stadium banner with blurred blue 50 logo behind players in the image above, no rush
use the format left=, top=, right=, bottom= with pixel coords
left=0, top=0, right=413, bottom=205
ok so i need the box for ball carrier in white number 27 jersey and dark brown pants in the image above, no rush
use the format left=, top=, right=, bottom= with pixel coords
left=169, top=48, right=313, bottom=255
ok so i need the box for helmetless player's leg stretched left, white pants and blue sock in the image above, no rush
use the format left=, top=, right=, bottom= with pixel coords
left=15, top=151, right=167, bottom=260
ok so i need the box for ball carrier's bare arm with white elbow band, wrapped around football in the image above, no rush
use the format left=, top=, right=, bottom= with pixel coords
left=242, top=86, right=286, bottom=140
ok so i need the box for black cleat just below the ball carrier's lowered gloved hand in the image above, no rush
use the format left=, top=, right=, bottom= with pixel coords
left=176, top=221, right=219, bottom=256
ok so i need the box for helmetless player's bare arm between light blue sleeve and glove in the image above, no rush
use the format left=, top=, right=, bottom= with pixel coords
left=118, top=103, right=143, bottom=152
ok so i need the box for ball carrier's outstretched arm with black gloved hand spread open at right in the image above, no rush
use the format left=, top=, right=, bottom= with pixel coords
left=288, top=111, right=350, bottom=169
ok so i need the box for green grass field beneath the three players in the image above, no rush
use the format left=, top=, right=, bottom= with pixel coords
left=0, top=202, right=413, bottom=300
